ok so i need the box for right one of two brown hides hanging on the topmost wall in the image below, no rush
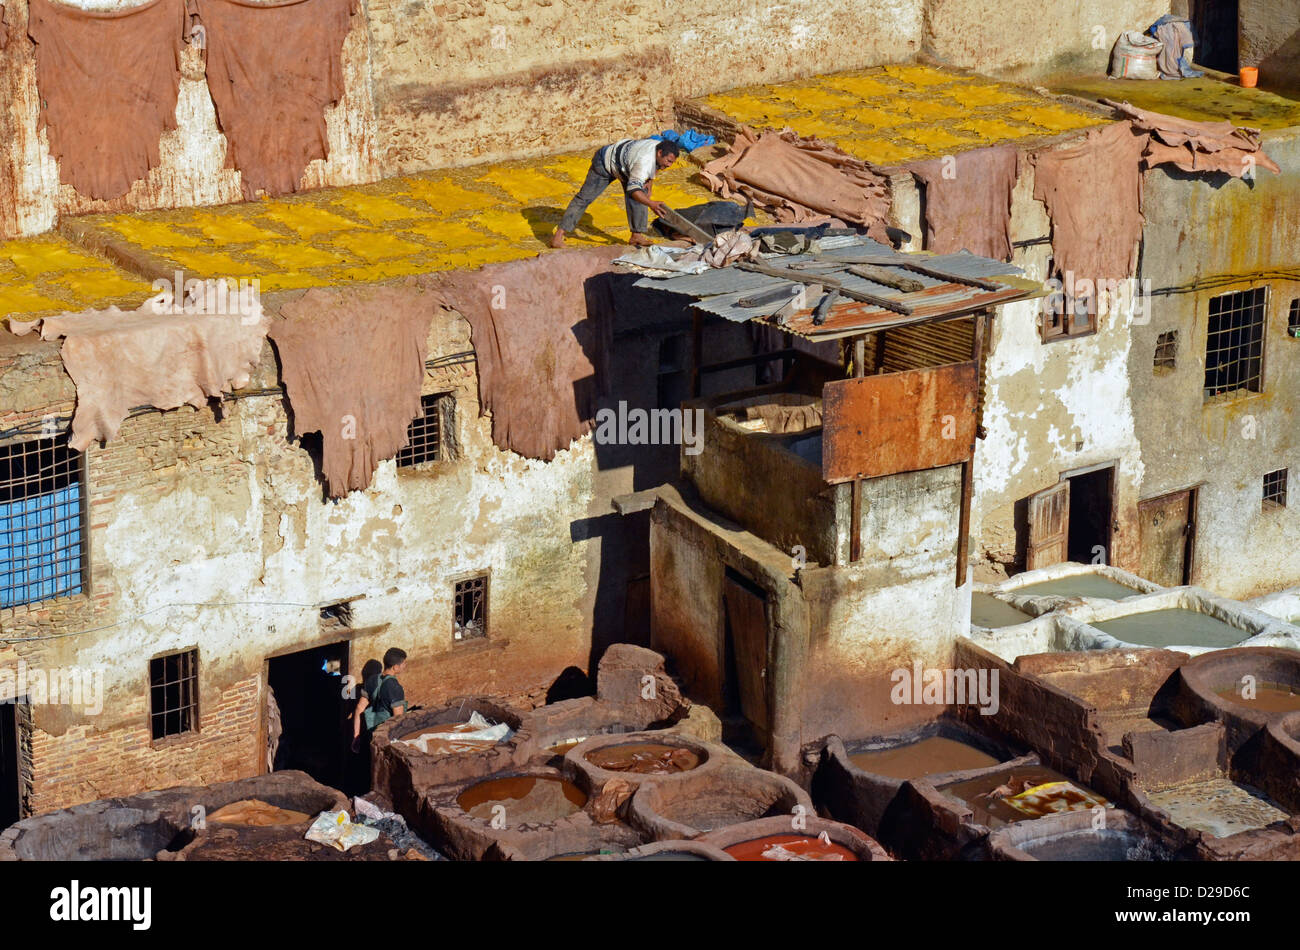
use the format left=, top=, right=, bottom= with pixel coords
left=195, top=0, right=354, bottom=199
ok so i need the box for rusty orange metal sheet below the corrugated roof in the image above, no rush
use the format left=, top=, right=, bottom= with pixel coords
left=822, top=361, right=978, bottom=483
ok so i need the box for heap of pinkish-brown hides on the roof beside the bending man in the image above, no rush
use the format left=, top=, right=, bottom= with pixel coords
left=703, top=126, right=889, bottom=240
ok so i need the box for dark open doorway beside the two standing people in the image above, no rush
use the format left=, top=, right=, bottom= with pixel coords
left=267, top=641, right=351, bottom=793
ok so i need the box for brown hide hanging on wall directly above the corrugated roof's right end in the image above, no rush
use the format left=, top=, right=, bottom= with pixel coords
left=907, top=146, right=1019, bottom=261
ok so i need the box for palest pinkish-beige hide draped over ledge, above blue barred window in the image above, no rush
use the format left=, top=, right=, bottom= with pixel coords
left=9, top=291, right=267, bottom=452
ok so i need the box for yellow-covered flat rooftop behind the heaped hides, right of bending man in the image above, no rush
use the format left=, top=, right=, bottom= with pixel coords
left=692, top=64, right=1112, bottom=165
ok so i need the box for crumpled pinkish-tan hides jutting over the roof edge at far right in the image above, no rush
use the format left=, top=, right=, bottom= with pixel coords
left=1113, top=103, right=1282, bottom=178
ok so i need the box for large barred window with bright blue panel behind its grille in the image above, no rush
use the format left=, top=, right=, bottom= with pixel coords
left=0, top=434, right=86, bottom=608
